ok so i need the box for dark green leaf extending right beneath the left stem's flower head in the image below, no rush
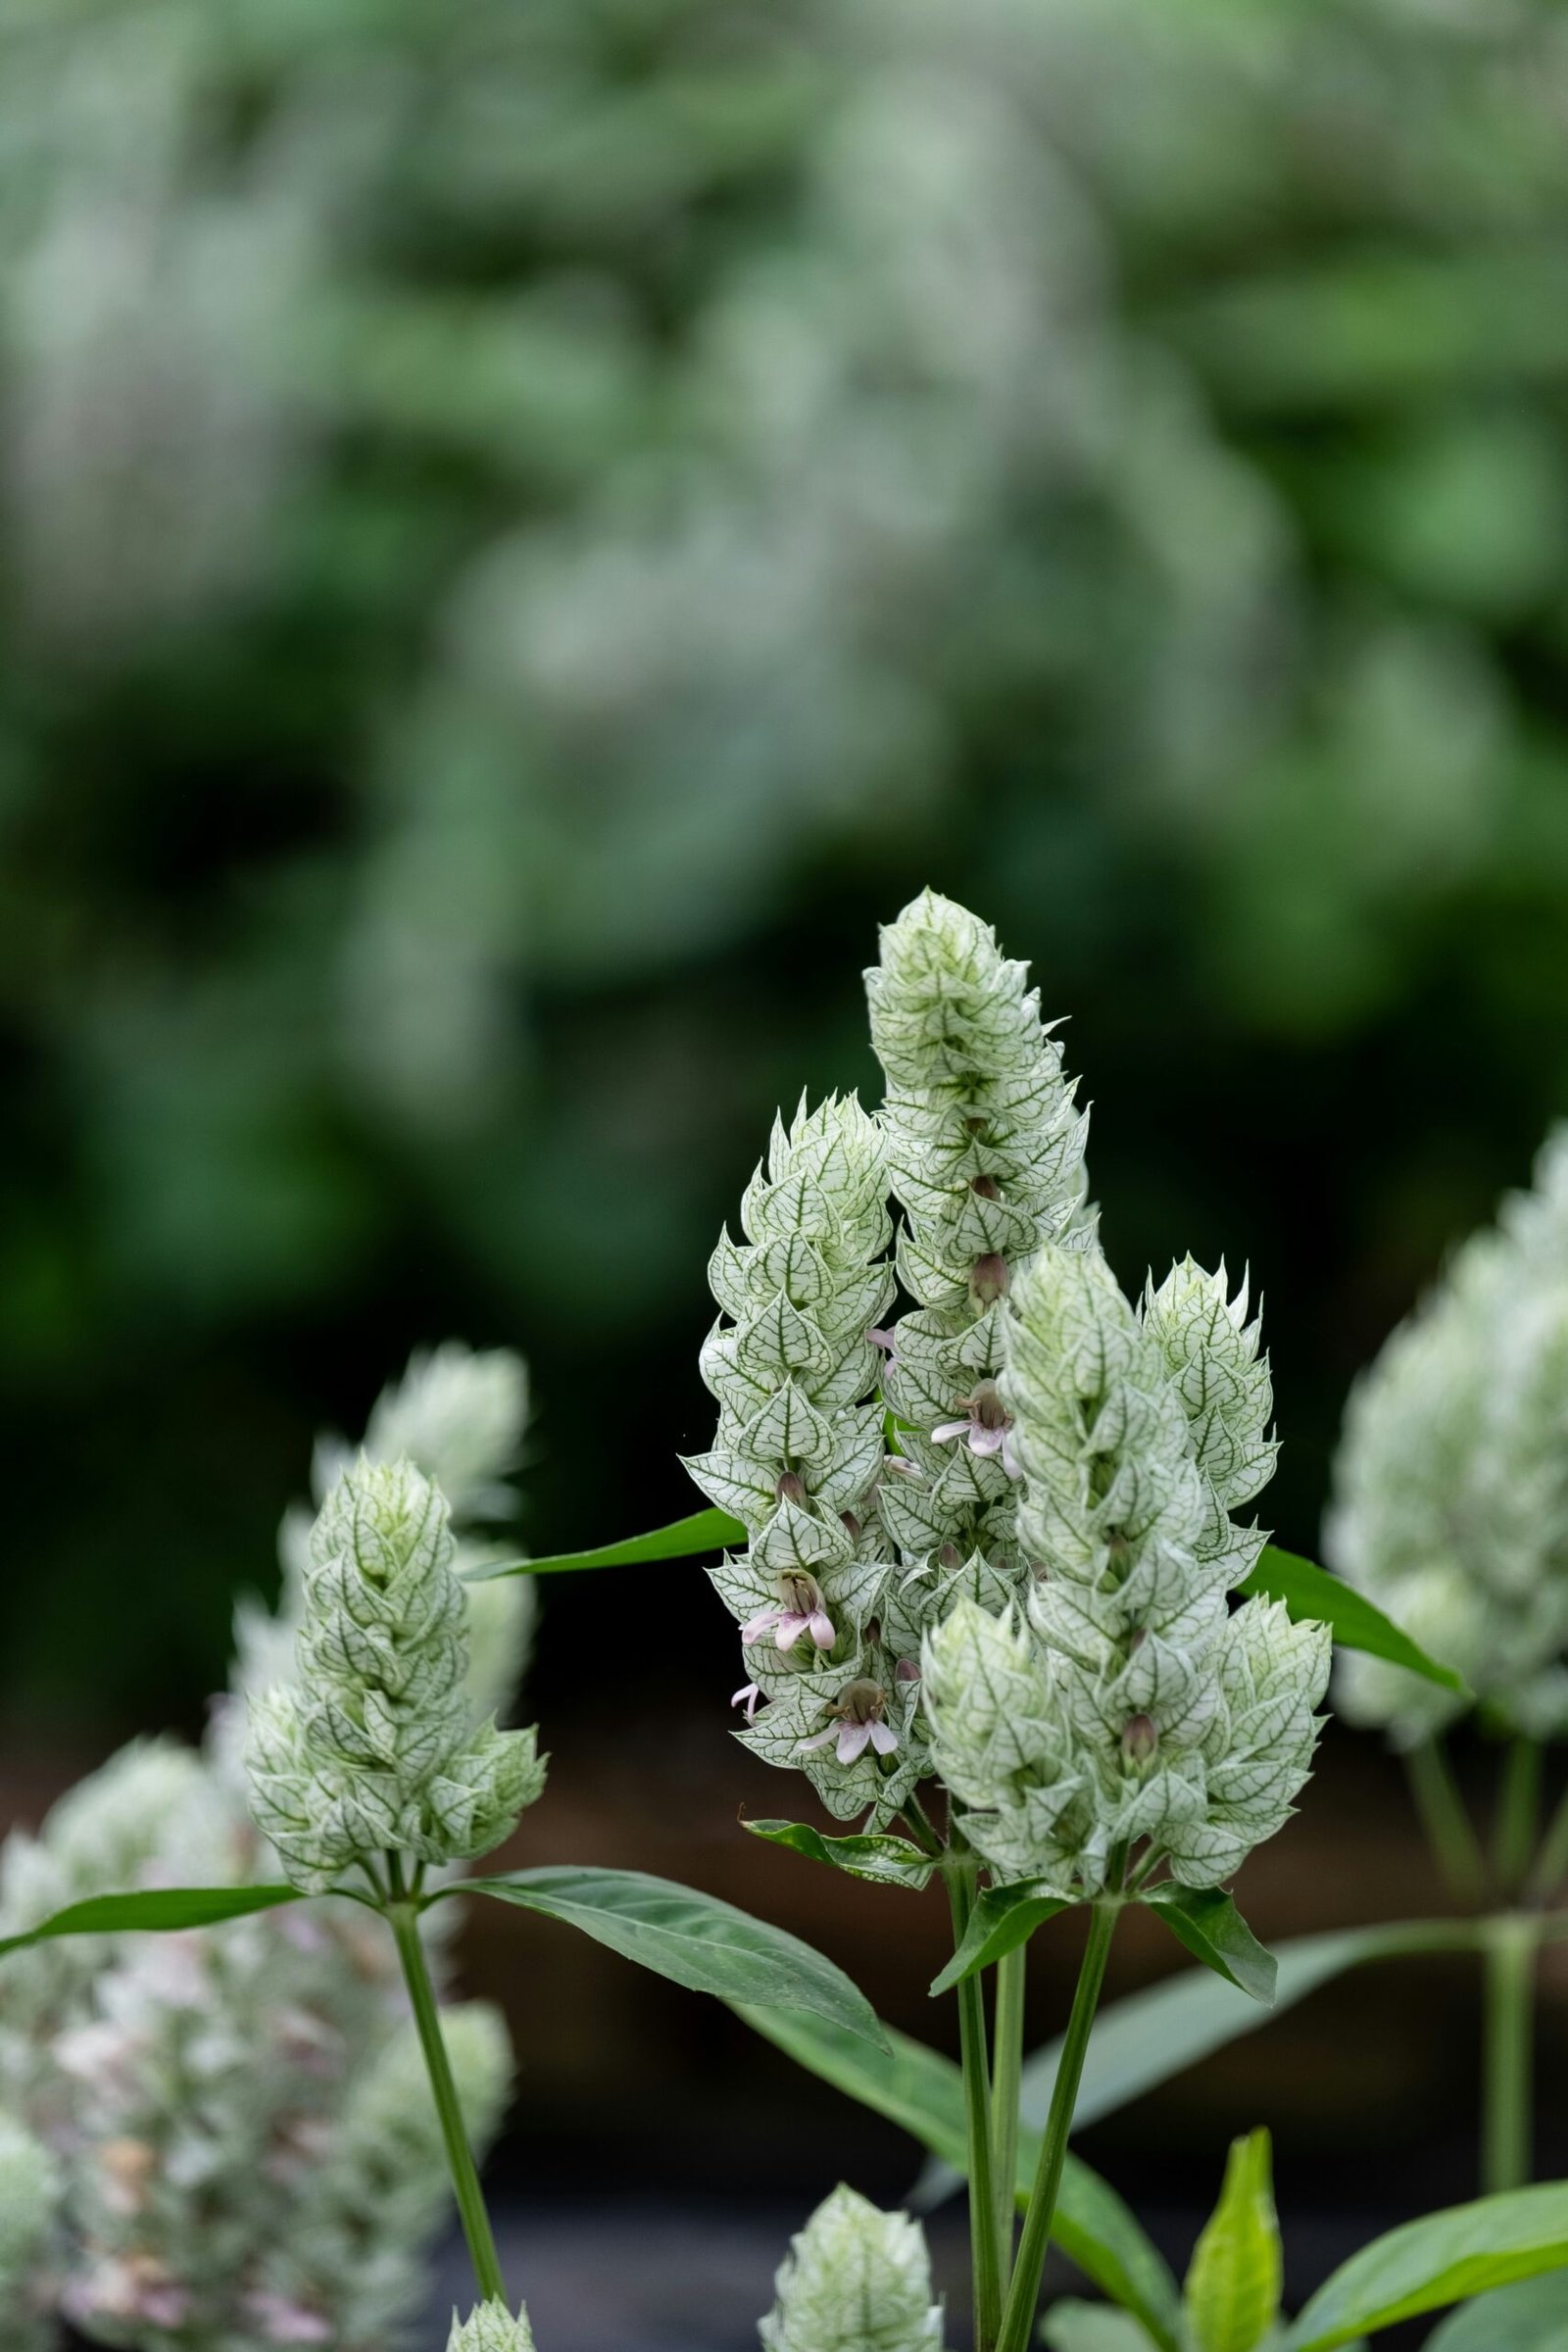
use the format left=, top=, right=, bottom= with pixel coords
left=461, top=1868, right=882, bottom=2044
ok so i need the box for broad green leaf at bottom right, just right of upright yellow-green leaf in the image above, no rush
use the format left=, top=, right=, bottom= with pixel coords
left=1286, top=2180, right=1568, bottom=2352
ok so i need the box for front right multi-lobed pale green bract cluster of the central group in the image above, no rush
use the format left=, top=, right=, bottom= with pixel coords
left=924, top=1247, right=1328, bottom=1895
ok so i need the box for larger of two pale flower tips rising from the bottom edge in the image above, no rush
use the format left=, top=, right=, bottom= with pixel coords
left=760, top=2187, right=943, bottom=2352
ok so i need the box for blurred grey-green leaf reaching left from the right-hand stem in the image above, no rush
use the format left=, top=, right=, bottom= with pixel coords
left=914, top=1919, right=1476, bottom=2211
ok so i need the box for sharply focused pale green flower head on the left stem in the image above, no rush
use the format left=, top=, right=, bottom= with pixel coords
left=247, top=1458, right=543, bottom=1891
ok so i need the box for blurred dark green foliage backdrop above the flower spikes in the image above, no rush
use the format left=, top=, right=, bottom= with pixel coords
left=0, top=0, right=1568, bottom=1719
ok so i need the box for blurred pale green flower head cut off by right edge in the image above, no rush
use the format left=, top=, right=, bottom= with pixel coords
left=1324, top=1127, right=1568, bottom=1747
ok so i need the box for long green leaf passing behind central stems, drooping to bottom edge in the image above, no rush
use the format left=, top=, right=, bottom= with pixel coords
left=733, top=2001, right=1180, bottom=2352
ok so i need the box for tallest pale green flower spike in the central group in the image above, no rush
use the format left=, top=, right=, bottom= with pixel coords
left=865, top=892, right=1091, bottom=1618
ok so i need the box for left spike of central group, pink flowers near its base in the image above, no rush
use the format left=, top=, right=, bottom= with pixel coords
left=686, top=1096, right=919, bottom=1818
